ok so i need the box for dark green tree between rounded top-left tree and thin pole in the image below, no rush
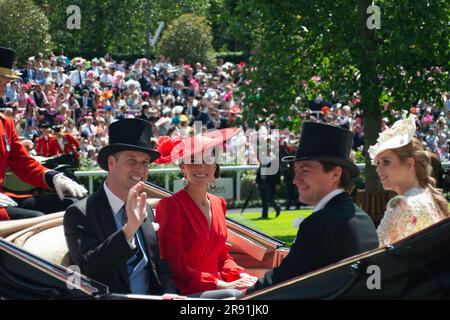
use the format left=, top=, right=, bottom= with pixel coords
left=41, top=0, right=145, bottom=58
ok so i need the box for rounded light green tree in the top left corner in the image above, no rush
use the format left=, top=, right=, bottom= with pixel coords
left=0, top=0, right=53, bottom=63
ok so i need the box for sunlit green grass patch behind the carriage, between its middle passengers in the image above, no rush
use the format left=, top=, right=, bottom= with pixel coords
left=227, top=210, right=312, bottom=247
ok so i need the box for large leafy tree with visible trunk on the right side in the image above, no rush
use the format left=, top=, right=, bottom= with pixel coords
left=240, top=0, right=450, bottom=191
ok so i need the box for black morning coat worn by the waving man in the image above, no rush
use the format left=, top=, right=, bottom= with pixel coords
left=64, top=186, right=177, bottom=295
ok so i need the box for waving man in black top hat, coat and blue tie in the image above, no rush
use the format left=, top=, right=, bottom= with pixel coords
left=64, top=119, right=176, bottom=294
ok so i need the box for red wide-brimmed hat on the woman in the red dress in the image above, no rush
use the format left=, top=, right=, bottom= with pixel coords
left=155, top=128, right=240, bottom=164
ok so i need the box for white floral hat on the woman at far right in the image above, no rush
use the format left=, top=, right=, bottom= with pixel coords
left=369, top=116, right=416, bottom=164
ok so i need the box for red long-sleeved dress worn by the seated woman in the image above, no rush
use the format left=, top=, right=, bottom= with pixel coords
left=156, top=190, right=245, bottom=294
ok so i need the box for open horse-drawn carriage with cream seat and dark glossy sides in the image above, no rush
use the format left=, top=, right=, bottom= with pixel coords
left=0, top=185, right=450, bottom=300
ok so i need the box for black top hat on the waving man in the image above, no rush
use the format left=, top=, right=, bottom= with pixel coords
left=97, top=118, right=160, bottom=171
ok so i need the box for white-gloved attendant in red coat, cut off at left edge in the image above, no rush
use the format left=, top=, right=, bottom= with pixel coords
left=0, top=47, right=87, bottom=221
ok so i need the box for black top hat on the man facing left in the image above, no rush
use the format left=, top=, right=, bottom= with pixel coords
left=283, top=122, right=359, bottom=177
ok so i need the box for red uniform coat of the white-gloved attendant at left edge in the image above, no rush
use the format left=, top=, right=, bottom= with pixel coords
left=0, top=114, right=48, bottom=221
